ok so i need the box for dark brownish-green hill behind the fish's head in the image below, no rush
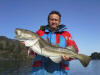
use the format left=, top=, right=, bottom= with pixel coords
left=0, top=36, right=33, bottom=60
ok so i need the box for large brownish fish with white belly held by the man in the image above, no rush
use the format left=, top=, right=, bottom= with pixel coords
left=15, top=28, right=91, bottom=67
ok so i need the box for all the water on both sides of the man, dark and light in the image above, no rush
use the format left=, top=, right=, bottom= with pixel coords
left=0, top=60, right=100, bottom=75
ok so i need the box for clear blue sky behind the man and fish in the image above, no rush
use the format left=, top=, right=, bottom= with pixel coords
left=0, top=0, right=100, bottom=55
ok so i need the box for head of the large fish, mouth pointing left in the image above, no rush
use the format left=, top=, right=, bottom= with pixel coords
left=15, top=28, right=37, bottom=41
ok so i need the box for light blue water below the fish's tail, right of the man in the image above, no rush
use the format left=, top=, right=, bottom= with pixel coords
left=70, top=60, right=100, bottom=75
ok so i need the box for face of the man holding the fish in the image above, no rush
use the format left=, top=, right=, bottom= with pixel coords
left=48, top=14, right=60, bottom=28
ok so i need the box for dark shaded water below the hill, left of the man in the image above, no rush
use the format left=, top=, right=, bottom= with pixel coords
left=0, top=60, right=32, bottom=75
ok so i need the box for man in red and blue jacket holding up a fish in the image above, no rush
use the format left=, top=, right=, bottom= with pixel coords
left=28, top=11, right=78, bottom=75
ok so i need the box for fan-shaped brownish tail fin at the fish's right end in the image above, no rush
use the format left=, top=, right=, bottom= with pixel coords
left=77, top=54, right=91, bottom=67
